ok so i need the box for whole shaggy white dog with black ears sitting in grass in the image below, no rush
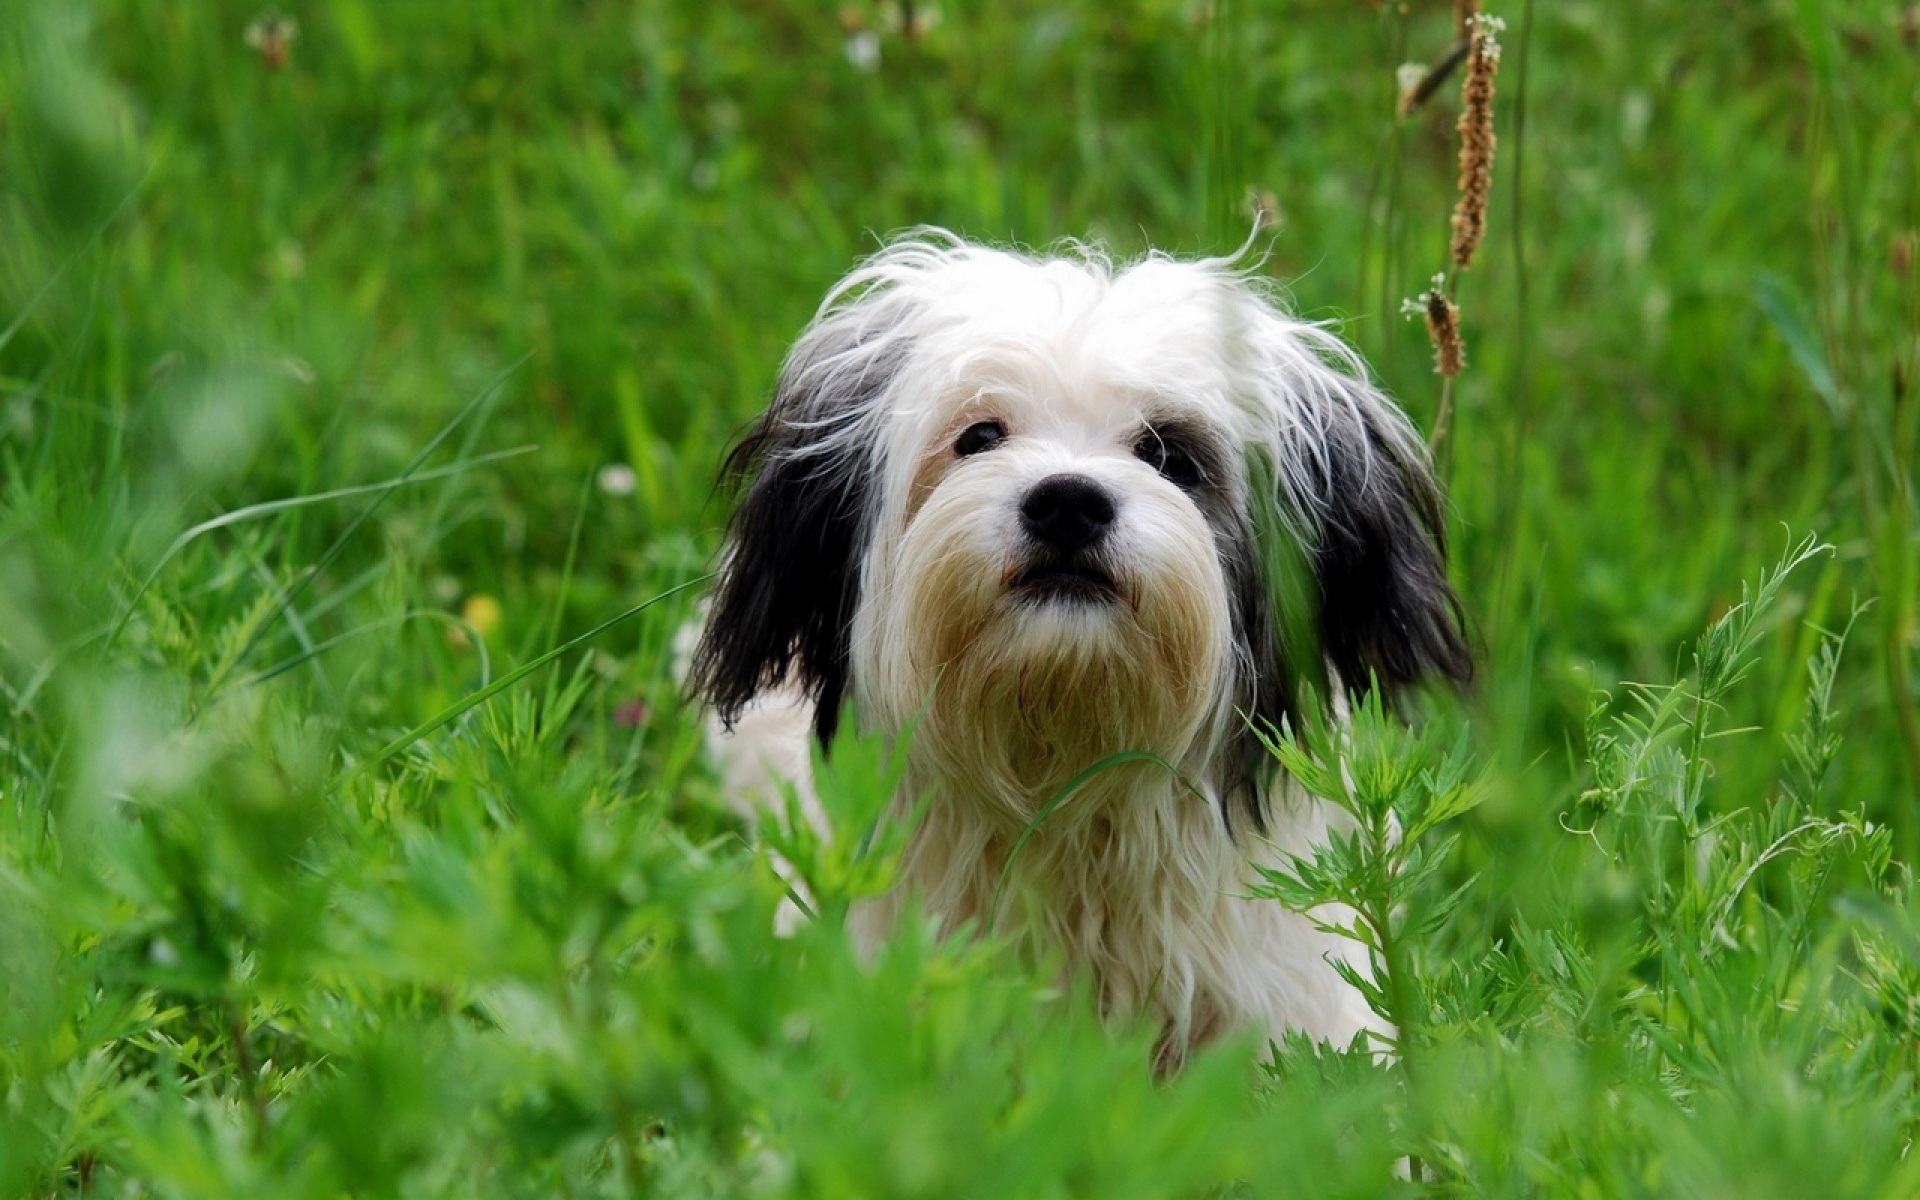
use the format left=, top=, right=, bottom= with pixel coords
left=691, top=230, right=1471, bottom=1062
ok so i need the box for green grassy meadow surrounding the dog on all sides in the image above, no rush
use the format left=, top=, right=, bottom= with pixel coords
left=0, top=0, right=1920, bottom=1198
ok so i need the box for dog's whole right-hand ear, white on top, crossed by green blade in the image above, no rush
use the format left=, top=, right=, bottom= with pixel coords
left=1215, top=293, right=1473, bottom=829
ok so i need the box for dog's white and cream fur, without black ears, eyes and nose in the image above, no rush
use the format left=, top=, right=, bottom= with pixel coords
left=698, top=230, right=1443, bottom=1062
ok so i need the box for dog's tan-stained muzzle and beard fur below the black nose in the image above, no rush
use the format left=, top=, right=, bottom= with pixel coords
left=864, top=478, right=1231, bottom=824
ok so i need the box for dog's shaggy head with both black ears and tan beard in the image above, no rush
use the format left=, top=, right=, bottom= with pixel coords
left=693, top=232, right=1471, bottom=820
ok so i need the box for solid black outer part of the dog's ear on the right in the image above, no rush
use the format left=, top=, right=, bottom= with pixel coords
left=1311, top=376, right=1473, bottom=701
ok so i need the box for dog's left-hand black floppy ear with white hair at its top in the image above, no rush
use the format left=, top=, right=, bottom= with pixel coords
left=689, top=303, right=906, bottom=745
